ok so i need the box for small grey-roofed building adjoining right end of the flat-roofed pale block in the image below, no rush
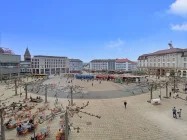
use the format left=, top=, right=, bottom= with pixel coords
left=69, top=59, right=83, bottom=72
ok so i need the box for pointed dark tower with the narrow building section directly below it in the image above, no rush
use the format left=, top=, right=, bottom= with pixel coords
left=20, top=48, right=32, bottom=73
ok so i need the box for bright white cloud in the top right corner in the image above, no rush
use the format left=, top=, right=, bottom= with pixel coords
left=169, top=0, right=187, bottom=17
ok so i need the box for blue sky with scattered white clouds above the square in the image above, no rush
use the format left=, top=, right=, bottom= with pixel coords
left=0, top=0, right=187, bottom=62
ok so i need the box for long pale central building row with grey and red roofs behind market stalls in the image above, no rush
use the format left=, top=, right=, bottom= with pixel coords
left=90, top=59, right=136, bottom=71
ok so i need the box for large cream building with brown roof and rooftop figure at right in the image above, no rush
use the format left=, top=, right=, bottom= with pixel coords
left=138, top=43, right=187, bottom=77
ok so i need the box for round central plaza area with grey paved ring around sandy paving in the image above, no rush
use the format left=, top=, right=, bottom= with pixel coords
left=28, top=77, right=148, bottom=99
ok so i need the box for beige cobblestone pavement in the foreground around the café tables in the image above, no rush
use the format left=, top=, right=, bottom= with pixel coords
left=0, top=76, right=187, bottom=140
